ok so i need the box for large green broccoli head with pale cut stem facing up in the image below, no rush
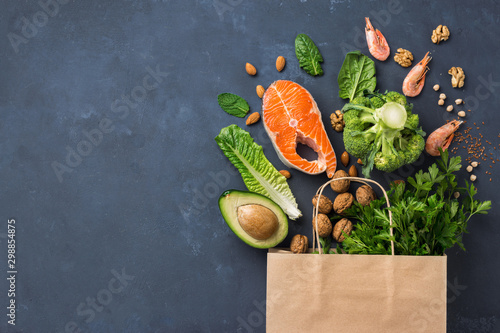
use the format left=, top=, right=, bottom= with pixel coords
left=342, top=91, right=425, bottom=177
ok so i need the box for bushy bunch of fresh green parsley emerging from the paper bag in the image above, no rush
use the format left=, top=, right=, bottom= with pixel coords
left=342, top=151, right=491, bottom=255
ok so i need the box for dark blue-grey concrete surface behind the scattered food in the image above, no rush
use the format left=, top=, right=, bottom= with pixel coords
left=0, top=0, right=500, bottom=332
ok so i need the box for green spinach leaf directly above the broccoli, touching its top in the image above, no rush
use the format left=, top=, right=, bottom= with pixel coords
left=337, top=51, right=377, bottom=101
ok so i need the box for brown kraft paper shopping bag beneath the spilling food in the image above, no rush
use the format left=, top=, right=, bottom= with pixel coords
left=266, top=177, right=446, bottom=333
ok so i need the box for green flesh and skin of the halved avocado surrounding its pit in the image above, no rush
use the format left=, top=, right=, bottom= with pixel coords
left=219, top=190, right=288, bottom=249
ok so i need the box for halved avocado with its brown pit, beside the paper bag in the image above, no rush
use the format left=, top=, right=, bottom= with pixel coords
left=219, top=190, right=288, bottom=249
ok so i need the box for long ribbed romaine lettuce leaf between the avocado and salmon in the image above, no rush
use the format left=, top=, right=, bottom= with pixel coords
left=215, top=125, right=302, bottom=220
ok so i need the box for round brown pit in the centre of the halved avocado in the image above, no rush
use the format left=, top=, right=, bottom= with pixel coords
left=237, top=205, right=278, bottom=240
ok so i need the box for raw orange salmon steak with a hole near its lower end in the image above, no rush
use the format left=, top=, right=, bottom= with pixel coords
left=262, top=80, right=337, bottom=178
